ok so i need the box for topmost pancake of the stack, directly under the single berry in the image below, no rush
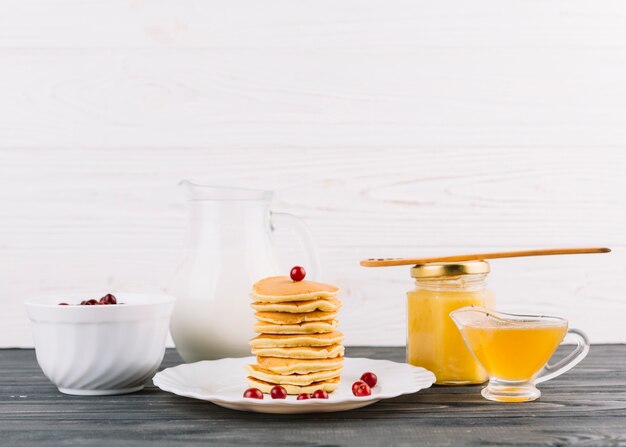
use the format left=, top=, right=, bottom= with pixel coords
left=252, top=276, right=339, bottom=303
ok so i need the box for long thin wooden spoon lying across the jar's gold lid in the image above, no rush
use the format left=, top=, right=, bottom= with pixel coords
left=361, top=247, right=611, bottom=267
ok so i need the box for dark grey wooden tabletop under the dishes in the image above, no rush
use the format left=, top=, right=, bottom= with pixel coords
left=0, top=345, right=626, bottom=447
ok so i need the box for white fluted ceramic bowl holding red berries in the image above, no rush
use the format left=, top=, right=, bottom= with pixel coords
left=25, top=293, right=175, bottom=396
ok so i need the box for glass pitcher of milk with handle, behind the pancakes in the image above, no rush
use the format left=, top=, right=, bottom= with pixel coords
left=170, top=184, right=317, bottom=362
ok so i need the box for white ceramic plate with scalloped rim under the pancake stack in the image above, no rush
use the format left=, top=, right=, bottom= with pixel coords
left=153, top=357, right=435, bottom=414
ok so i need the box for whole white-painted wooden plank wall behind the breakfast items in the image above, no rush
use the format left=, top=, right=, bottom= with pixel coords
left=0, top=0, right=626, bottom=347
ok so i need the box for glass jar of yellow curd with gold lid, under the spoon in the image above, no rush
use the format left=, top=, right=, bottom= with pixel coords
left=406, top=261, right=493, bottom=385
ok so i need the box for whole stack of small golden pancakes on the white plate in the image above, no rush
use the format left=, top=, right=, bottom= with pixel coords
left=246, top=276, right=344, bottom=394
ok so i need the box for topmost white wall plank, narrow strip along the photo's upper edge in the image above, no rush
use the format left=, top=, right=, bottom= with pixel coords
left=0, top=0, right=626, bottom=50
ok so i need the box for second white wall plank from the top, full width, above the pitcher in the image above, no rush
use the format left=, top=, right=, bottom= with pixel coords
left=0, top=48, right=626, bottom=148
